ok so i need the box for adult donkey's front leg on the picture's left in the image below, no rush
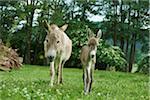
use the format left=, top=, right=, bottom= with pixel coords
left=50, top=62, right=55, bottom=86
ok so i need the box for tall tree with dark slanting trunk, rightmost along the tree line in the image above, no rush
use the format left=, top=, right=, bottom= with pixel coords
left=129, top=0, right=148, bottom=72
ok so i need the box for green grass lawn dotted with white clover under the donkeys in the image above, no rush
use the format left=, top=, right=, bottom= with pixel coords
left=0, top=65, right=150, bottom=100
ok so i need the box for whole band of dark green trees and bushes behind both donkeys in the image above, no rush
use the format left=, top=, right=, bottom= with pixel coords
left=0, top=0, right=150, bottom=72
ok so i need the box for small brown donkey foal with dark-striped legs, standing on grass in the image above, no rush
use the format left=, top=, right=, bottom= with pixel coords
left=80, top=29, right=102, bottom=95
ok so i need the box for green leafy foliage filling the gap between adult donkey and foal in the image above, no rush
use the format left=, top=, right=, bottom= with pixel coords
left=67, top=20, right=87, bottom=67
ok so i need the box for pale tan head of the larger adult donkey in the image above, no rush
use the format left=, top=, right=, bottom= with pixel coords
left=44, top=21, right=68, bottom=62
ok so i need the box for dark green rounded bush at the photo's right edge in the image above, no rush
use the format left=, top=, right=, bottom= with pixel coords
left=137, top=55, right=150, bottom=74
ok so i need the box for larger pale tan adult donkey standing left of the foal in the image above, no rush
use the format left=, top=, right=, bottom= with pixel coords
left=44, top=21, right=72, bottom=86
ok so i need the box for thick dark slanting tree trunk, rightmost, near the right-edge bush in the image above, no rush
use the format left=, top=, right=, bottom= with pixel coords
left=128, top=33, right=136, bottom=72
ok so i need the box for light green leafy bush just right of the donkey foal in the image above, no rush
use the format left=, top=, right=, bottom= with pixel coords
left=97, top=40, right=127, bottom=71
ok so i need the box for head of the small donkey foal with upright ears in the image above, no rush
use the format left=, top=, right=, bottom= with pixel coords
left=88, top=29, right=102, bottom=59
